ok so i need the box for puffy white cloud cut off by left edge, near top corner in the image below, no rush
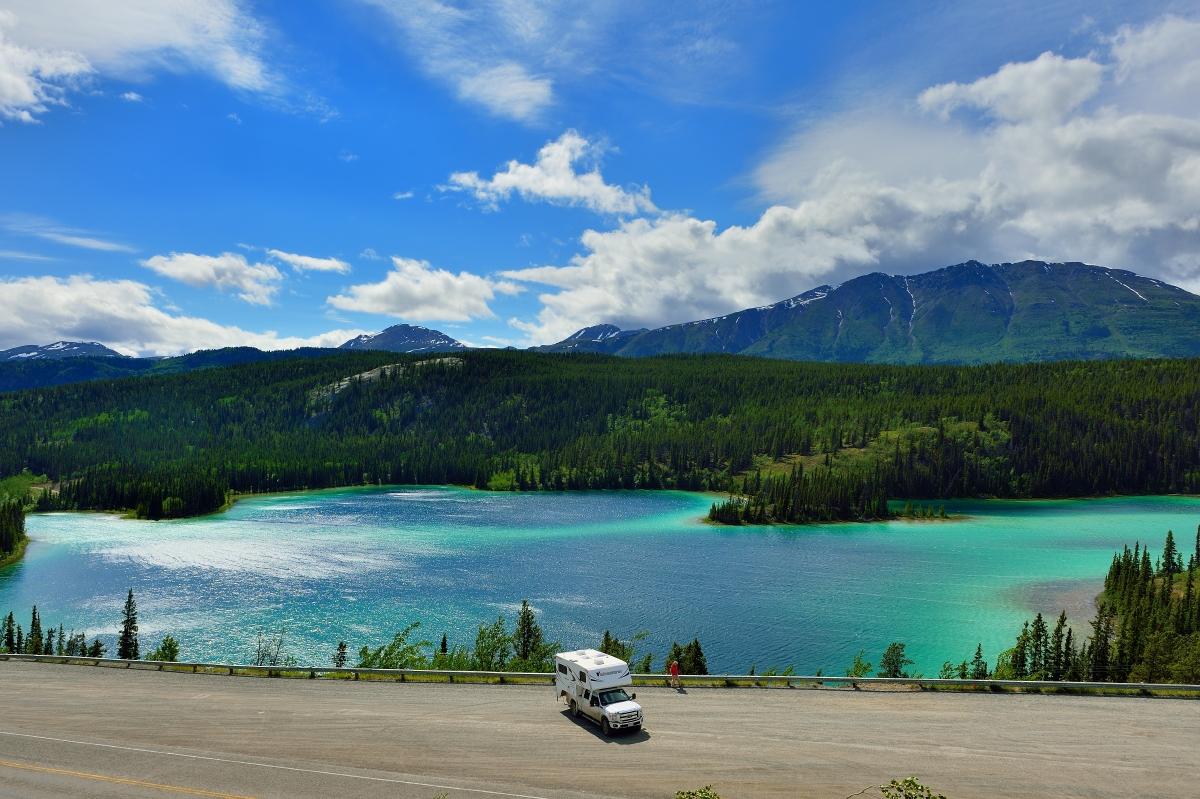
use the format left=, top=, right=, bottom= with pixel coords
left=0, top=11, right=91, bottom=122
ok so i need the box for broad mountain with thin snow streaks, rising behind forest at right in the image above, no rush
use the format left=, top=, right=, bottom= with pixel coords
left=538, top=260, right=1200, bottom=364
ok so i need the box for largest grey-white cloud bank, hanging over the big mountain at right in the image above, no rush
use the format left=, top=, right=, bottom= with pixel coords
left=505, top=18, right=1200, bottom=343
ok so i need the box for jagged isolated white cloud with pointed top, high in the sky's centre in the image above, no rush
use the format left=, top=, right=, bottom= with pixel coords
left=442, top=131, right=658, bottom=215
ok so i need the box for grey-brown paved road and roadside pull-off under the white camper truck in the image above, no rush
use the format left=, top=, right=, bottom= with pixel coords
left=0, top=662, right=1200, bottom=799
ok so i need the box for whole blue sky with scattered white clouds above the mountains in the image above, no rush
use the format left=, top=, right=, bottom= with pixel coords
left=0, top=0, right=1200, bottom=354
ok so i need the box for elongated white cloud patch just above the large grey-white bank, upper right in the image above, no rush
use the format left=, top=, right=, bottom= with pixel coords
left=917, top=53, right=1104, bottom=121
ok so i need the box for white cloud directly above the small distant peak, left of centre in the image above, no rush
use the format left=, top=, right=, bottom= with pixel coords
left=328, top=258, right=521, bottom=322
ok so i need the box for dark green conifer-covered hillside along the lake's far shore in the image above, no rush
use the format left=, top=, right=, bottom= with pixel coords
left=0, top=352, right=1200, bottom=521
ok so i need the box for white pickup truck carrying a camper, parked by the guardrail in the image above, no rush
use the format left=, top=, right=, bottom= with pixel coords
left=554, top=649, right=642, bottom=735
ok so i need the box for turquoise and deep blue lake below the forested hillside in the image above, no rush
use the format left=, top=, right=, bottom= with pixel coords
left=0, top=487, right=1200, bottom=674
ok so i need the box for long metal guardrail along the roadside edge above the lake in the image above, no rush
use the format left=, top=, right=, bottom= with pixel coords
left=0, top=653, right=1200, bottom=697
